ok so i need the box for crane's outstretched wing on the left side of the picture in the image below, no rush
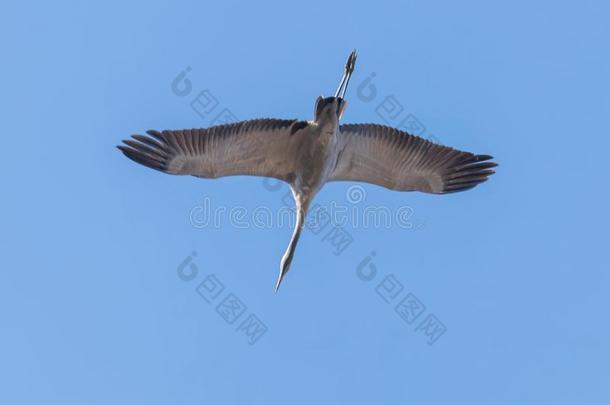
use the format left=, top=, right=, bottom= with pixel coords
left=118, top=119, right=306, bottom=181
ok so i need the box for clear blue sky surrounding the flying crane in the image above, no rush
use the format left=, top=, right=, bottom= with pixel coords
left=0, top=0, right=610, bottom=405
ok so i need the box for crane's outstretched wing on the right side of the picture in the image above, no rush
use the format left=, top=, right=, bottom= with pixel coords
left=329, top=124, right=497, bottom=194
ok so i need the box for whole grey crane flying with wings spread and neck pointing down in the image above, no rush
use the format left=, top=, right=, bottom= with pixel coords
left=118, top=51, right=497, bottom=291
